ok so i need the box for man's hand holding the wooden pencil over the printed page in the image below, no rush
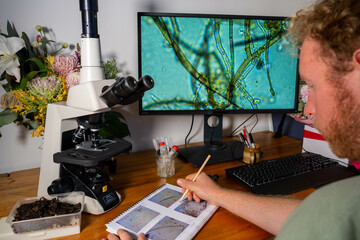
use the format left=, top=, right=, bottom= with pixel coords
left=177, top=172, right=222, bottom=205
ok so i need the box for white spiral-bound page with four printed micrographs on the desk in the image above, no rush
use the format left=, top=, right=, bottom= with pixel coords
left=106, top=184, right=218, bottom=240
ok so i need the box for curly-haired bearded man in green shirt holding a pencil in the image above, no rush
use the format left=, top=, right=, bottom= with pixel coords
left=102, top=0, right=360, bottom=240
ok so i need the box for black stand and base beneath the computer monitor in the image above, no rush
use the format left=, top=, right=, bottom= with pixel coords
left=178, top=114, right=244, bottom=167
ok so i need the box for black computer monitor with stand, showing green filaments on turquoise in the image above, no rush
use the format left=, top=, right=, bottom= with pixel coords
left=138, top=12, right=299, bottom=165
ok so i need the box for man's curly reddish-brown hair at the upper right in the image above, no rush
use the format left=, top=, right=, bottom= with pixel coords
left=289, top=0, right=360, bottom=72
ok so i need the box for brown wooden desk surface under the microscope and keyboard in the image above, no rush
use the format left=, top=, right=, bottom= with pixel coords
left=0, top=132, right=313, bottom=240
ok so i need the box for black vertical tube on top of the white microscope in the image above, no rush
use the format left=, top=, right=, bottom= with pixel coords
left=80, top=0, right=99, bottom=38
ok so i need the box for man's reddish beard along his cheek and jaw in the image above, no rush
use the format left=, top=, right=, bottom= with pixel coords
left=315, top=81, right=360, bottom=162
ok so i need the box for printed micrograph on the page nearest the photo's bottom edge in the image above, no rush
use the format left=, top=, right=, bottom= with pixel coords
left=145, top=217, right=189, bottom=240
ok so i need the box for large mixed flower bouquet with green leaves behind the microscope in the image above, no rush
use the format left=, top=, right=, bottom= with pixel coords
left=0, top=22, right=130, bottom=138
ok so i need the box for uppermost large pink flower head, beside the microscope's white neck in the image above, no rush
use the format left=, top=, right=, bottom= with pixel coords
left=52, top=55, right=80, bottom=78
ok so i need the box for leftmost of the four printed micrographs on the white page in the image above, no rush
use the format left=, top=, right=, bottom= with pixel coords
left=117, top=206, right=160, bottom=232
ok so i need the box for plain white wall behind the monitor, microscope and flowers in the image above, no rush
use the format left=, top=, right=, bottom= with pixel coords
left=0, top=0, right=312, bottom=173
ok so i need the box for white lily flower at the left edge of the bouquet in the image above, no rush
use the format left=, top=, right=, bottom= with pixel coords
left=0, top=35, right=25, bottom=82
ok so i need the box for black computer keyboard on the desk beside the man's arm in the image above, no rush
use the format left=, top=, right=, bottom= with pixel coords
left=225, top=152, right=358, bottom=195
